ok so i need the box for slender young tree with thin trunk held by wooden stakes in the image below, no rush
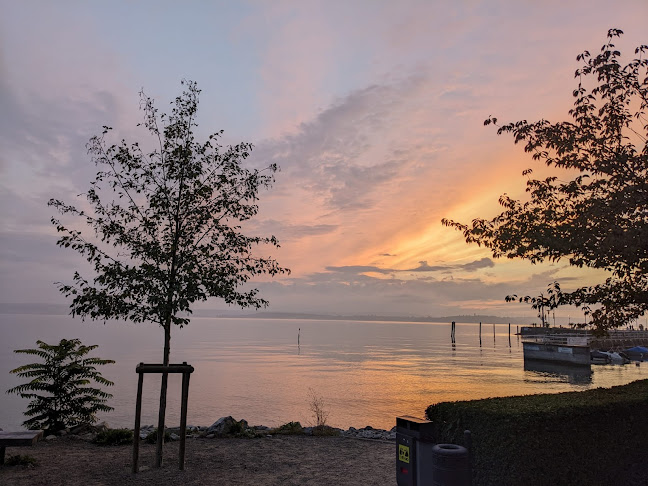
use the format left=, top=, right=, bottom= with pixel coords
left=49, top=81, right=288, bottom=466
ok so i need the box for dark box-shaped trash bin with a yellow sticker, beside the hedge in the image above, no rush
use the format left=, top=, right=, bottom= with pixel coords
left=396, top=415, right=434, bottom=486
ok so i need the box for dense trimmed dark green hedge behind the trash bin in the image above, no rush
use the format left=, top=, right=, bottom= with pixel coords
left=426, top=380, right=648, bottom=486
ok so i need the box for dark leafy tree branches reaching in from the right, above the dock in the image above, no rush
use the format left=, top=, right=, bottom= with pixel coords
left=442, top=29, right=648, bottom=332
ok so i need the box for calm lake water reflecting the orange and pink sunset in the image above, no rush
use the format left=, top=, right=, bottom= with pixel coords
left=0, top=315, right=648, bottom=430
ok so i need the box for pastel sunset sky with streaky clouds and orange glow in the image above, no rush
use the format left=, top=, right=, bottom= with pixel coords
left=0, top=0, right=648, bottom=321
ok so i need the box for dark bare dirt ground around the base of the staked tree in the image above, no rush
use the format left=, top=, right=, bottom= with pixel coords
left=0, top=436, right=396, bottom=486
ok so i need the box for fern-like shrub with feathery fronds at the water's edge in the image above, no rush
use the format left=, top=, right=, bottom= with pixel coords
left=7, top=339, right=114, bottom=432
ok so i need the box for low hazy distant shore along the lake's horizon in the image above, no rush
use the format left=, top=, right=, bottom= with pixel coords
left=0, top=303, right=538, bottom=325
